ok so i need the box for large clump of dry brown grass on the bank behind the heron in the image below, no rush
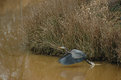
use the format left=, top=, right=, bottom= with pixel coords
left=26, top=0, right=121, bottom=62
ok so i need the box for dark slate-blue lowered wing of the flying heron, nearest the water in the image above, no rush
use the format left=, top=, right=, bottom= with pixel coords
left=59, top=53, right=84, bottom=65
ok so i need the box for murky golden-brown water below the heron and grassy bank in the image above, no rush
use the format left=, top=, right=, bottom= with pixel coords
left=0, top=53, right=121, bottom=80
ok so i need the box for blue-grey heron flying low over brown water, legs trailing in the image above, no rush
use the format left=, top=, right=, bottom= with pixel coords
left=59, top=47, right=95, bottom=66
